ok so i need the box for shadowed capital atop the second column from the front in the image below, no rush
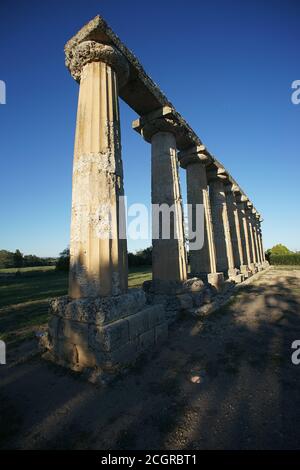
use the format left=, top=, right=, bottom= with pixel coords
left=132, top=106, right=186, bottom=143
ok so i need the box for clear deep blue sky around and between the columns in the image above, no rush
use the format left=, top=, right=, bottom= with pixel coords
left=0, top=0, right=300, bottom=256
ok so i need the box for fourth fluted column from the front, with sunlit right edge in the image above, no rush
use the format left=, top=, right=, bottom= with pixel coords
left=208, top=168, right=238, bottom=278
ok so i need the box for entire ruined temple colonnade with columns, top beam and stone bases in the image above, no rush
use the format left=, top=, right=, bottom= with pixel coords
left=43, top=16, right=267, bottom=381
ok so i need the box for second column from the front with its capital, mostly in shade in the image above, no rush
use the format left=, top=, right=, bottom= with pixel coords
left=133, top=107, right=187, bottom=282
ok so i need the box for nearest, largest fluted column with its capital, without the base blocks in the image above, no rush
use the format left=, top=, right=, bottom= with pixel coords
left=67, top=41, right=129, bottom=298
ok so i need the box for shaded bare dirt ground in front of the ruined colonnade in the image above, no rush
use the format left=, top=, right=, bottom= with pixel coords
left=0, top=269, right=300, bottom=449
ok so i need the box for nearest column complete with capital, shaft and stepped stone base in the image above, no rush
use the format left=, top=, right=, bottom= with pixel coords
left=46, top=24, right=168, bottom=380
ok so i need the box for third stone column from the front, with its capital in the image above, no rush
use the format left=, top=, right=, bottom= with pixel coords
left=178, top=146, right=224, bottom=289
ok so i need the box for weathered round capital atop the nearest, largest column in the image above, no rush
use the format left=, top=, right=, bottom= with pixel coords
left=65, top=41, right=129, bottom=86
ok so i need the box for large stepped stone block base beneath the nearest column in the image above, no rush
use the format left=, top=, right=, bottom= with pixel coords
left=44, top=289, right=168, bottom=378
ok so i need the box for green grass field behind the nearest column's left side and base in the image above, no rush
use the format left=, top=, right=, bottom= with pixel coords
left=0, top=266, right=151, bottom=344
